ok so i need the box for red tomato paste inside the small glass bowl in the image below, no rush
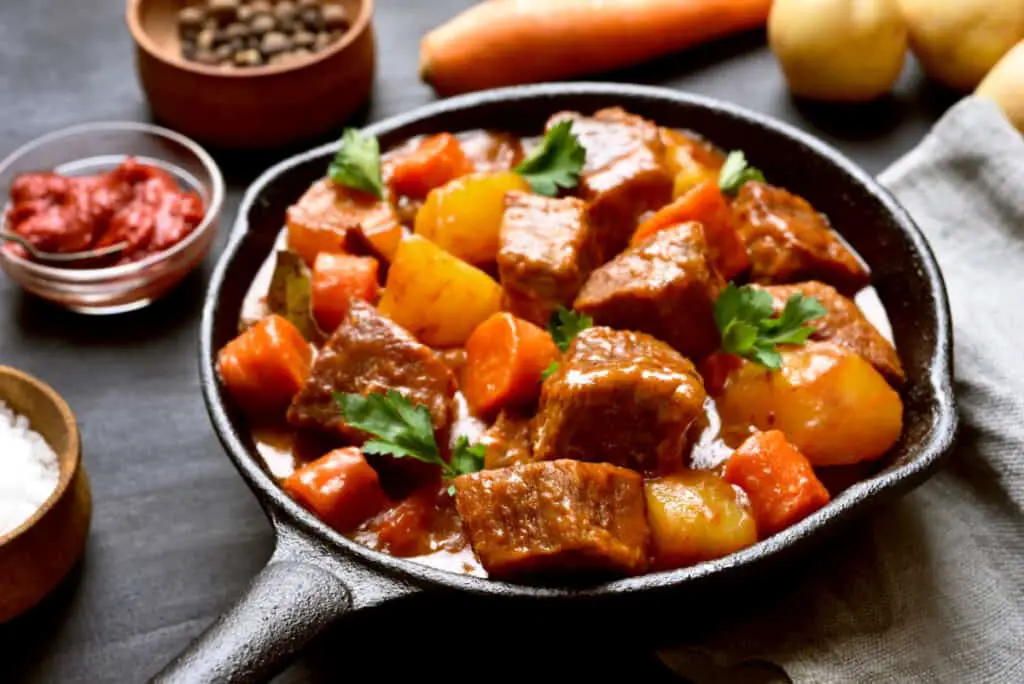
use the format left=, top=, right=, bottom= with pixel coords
left=4, top=158, right=204, bottom=264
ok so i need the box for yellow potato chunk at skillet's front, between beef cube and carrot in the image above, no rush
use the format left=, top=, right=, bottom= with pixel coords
left=644, top=470, right=758, bottom=569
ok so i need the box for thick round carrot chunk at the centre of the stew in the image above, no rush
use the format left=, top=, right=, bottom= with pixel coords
left=462, top=311, right=559, bottom=416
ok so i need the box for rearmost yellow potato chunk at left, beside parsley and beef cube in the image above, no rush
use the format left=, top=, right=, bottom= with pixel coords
left=416, top=172, right=529, bottom=263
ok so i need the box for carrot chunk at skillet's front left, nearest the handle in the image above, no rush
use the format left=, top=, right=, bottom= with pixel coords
left=282, top=446, right=388, bottom=532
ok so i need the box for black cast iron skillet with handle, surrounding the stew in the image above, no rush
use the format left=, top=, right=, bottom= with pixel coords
left=158, top=83, right=956, bottom=682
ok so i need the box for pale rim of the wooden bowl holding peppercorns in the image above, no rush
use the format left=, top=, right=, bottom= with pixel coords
left=125, top=0, right=374, bottom=79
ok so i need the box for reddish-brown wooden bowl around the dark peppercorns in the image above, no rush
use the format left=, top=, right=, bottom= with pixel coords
left=126, top=0, right=375, bottom=147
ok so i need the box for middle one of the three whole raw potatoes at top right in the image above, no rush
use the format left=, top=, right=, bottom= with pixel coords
left=899, top=0, right=1024, bottom=90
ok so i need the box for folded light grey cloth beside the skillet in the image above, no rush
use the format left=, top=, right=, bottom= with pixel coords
left=659, top=98, right=1024, bottom=684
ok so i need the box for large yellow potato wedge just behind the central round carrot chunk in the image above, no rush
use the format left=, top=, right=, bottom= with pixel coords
left=378, top=236, right=502, bottom=348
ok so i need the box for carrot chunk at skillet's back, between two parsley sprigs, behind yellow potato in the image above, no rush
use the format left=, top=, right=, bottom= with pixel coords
left=388, top=133, right=473, bottom=198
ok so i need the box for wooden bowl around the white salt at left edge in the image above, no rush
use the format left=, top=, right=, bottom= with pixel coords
left=0, top=366, right=92, bottom=623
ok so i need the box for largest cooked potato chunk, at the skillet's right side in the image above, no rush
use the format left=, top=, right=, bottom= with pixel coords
left=715, top=342, right=903, bottom=466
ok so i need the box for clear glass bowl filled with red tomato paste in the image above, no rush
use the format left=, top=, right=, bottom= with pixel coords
left=0, top=123, right=224, bottom=313
